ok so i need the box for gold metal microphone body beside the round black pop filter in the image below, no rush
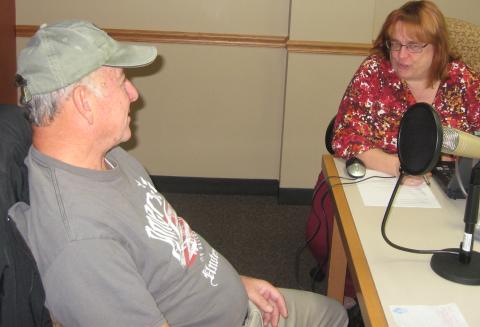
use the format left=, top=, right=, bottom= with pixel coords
left=442, top=127, right=480, bottom=158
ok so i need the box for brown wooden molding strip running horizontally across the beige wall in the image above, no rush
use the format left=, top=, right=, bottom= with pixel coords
left=15, top=25, right=371, bottom=56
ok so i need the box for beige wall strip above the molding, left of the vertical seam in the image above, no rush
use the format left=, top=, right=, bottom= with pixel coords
left=16, top=0, right=290, bottom=35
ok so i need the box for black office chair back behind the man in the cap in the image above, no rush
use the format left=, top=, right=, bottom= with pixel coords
left=0, top=105, right=52, bottom=327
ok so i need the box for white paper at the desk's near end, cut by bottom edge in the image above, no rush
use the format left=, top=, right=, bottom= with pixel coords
left=390, top=303, right=468, bottom=327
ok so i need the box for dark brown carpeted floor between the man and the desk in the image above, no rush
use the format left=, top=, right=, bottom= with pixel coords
left=164, top=193, right=322, bottom=290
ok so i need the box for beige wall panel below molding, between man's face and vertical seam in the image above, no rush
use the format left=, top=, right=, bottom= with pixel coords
left=125, top=45, right=285, bottom=179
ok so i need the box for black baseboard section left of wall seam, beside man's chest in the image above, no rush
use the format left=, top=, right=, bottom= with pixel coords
left=151, top=176, right=278, bottom=196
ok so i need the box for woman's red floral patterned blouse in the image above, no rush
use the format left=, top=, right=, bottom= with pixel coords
left=332, top=55, right=480, bottom=158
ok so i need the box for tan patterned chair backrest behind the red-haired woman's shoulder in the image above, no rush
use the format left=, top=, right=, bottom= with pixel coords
left=446, top=17, right=480, bottom=72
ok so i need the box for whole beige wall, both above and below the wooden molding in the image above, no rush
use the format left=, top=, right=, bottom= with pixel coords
left=16, top=0, right=480, bottom=188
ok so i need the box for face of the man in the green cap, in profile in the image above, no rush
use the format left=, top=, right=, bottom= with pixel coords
left=90, top=66, right=138, bottom=147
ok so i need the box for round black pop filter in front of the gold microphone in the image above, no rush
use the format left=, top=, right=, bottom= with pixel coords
left=397, top=102, right=443, bottom=175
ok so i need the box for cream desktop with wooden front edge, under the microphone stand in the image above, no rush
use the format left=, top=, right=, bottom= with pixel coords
left=323, top=155, right=480, bottom=327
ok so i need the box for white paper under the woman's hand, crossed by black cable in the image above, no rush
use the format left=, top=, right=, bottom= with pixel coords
left=357, top=171, right=441, bottom=208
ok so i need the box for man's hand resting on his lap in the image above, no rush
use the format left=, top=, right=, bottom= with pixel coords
left=240, top=276, right=288, bottom=327
